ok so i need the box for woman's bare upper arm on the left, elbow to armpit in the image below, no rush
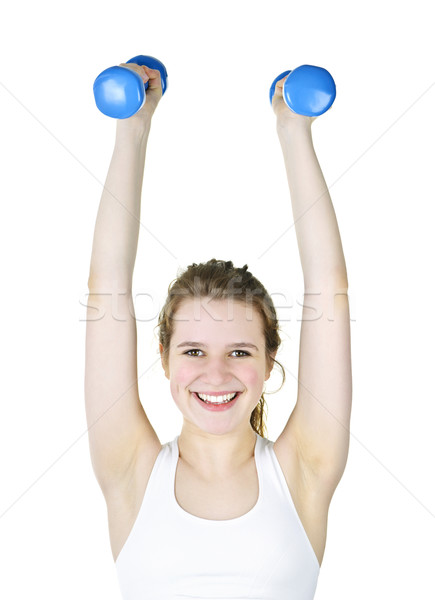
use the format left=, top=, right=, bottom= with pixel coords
left=85, top=288, right=160, bottom=491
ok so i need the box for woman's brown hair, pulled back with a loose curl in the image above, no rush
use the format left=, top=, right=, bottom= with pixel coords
left=156, top=258, right=285, bottom=437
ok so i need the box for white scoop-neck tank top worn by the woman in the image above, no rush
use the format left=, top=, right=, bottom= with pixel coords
left=115, top=434, right=320, bottom=600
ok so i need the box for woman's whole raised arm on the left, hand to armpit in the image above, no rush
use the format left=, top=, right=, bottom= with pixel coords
left=85, top=65, right=162, bottom=493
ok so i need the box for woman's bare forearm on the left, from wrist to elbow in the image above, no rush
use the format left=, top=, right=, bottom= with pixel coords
left=88, top=120, right=151, bottom=289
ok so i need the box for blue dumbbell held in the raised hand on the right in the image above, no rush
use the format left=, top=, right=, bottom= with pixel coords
left=269, top=65, right=336, bottom=117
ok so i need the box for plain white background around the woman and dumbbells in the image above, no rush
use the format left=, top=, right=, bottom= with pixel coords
left=0, top=0, right=435, bottom=600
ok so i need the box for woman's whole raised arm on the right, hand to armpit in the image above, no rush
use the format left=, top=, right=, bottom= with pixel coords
left=272, top=78, right=352, bottom=498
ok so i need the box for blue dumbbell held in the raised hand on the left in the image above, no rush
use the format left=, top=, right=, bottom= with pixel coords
left=94, top=54, right=168, bottom=119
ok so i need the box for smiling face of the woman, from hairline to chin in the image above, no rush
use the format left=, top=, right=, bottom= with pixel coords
left=160, top=298, right=275, bottom=434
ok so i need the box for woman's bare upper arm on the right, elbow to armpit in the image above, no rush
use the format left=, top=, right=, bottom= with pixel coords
left=281, top=285, right=352, bottom=496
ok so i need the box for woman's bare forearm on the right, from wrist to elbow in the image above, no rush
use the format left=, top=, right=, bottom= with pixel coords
left=277, top=122, right=347, bottom=289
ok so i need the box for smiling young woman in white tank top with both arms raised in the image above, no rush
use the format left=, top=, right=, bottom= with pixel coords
left=85, top=64, right=352, bottom=600
